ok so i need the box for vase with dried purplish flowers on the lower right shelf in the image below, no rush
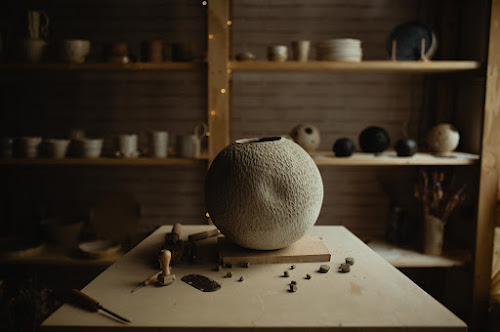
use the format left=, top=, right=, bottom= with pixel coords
left=414, top=170, right=466, bottom=255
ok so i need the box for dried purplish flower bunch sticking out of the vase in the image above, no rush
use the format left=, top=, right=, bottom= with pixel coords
left=414, top=170, right=466, bottom=222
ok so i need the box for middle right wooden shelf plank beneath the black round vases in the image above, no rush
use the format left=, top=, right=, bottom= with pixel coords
left=311, top=151, right=479, bottom=166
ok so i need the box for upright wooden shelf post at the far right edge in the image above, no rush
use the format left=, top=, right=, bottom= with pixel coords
left=470, top=0, right=500, bottom=331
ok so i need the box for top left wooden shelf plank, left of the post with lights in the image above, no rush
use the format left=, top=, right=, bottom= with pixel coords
left=0, top=62, right=205, bottom=71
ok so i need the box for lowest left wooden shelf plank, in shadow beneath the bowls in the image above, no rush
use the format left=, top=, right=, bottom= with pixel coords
left=0, top=245, right=124, bottom=267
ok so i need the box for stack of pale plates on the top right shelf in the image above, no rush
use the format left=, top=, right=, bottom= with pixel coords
left=316, top=38, right=363, bottom=62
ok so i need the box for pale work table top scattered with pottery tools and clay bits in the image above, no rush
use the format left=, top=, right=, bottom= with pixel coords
left=42, top=226, right=467, bottom=331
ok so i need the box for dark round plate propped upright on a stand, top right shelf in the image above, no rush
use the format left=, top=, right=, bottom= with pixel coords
left=386, top=22, right=437, bottom=61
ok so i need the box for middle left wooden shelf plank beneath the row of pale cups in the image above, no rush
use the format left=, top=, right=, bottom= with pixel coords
left=0, top=158, right=207, bottom=166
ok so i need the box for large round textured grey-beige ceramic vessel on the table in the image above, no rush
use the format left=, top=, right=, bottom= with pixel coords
left=205, top=137, right=323, bottom=250
